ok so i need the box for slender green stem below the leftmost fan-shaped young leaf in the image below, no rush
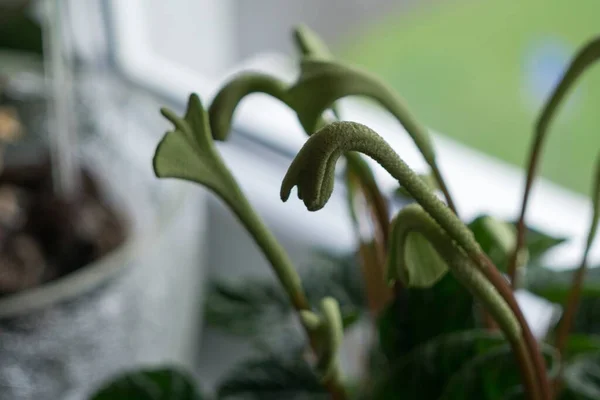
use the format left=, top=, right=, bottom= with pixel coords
left=224, top=185, right=347, bottom=400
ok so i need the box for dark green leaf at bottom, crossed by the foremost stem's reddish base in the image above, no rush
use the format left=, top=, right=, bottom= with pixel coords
left=440, top=344, right=560, bottom=400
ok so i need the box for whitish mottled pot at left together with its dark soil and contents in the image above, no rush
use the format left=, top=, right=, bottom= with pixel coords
left=0, top=4, right=209, bottom=400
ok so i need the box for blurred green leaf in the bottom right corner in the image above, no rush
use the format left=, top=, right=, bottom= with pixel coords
left=561, top=352, right=600, bottom=400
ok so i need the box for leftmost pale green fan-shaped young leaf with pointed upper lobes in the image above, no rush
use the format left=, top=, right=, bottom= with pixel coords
left=153, top=94, right=242, bottom=203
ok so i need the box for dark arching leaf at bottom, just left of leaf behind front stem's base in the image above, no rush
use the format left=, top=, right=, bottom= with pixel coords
left=371, top=330, right=506, bottom=400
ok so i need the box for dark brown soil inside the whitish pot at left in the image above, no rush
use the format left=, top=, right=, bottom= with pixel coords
left=0, top=161, right=126, bottom=297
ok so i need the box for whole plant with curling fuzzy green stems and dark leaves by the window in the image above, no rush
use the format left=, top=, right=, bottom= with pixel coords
left=93, top=27, right=600, bottom=400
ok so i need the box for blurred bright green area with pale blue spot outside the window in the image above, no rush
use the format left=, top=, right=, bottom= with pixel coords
left=339, top=0, right=600, bottom=194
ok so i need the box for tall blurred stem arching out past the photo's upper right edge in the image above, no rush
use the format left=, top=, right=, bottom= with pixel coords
left=508, top=37, right=600, bottom=283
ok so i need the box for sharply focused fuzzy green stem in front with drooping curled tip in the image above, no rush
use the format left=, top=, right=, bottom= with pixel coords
left=281, top=122, right=550, bottom=400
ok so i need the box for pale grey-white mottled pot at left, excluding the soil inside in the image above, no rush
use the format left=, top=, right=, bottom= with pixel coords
left=0, top=67, right=209, bottom=400
